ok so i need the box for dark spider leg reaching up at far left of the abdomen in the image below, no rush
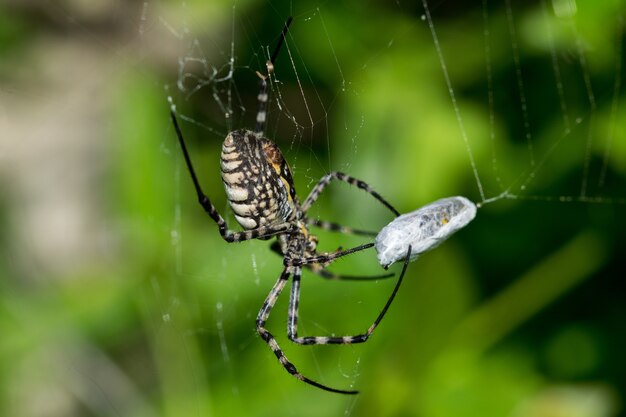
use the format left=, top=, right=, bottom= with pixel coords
left=170, top=109, right=293, bottom=243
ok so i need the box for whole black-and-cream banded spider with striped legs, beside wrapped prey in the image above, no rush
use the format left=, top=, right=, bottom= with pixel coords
left=170, top=17, right=411, bottom=394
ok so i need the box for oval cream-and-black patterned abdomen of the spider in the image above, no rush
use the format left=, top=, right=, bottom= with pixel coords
left=221, top=130, right=297, bottom=230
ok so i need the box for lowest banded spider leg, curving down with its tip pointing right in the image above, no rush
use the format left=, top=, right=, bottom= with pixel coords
left=256, top=267, right=358, bottom=394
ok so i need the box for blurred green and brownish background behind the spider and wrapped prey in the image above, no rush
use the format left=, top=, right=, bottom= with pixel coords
left=0, top=0, right=626, bottom=417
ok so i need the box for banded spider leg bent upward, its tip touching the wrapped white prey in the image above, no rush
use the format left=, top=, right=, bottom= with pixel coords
left=287, top=246, right=411, bottom=345
